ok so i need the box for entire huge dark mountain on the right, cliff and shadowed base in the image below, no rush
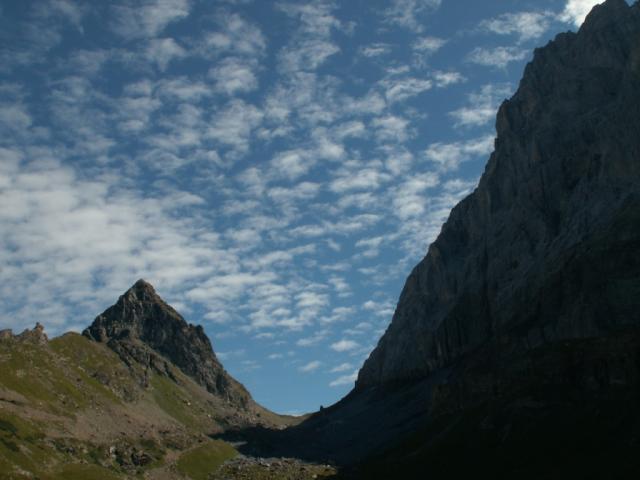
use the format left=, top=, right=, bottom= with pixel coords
left=260, top=0, right=640, bottom=478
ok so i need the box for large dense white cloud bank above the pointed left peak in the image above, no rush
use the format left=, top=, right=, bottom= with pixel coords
left=0, top=158, right=235, bottom=332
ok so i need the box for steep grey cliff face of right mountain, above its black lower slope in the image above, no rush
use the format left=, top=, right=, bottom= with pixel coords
left=356, top=0, right=640, bottom=391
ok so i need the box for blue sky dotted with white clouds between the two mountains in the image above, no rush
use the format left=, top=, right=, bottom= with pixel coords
left=0, top=0, right=608, bottom=414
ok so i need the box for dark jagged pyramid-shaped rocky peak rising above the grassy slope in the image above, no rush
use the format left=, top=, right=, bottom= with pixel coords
left=83, top=280, right=253, bottom=408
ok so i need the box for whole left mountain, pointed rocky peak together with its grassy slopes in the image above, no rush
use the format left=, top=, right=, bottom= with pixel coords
left=0, top=280, right=290, bottom=480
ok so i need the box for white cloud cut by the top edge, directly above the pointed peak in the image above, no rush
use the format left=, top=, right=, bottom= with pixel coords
left=111, top=0, right=190, bottom=39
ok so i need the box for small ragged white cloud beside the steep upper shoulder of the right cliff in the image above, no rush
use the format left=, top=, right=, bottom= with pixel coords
left=449, top=84, right=512, bottom=127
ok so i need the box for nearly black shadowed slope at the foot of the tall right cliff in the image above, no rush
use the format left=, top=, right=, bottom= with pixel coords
left=218, top=331, right=640, bottom=479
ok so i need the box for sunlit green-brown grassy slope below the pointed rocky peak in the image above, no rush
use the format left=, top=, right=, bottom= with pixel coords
left=0, top=334, right=264, bottom=480
